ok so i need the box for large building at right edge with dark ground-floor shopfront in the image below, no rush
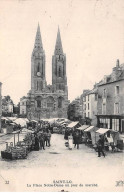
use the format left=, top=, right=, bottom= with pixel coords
left=97, top=60, right=124, bottom=133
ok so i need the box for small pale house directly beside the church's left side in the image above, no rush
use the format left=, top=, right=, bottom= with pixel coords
left=19, top=96, right=28, bottom=116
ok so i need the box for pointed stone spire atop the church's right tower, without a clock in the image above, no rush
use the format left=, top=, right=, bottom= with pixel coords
left=54, top=27, right=63, bottom=54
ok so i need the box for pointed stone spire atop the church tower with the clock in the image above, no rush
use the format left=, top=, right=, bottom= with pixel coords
left=34, top=23, right=43, bottom=50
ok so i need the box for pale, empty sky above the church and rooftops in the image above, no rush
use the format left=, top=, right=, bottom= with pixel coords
left=0, top=0, right=124, bottom=104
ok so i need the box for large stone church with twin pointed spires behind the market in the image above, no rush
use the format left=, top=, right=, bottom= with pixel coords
left=27, top=24, right=69, bottom=120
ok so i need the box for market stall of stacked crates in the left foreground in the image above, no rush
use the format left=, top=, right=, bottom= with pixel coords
left=1, top=129, right=35, bottom=160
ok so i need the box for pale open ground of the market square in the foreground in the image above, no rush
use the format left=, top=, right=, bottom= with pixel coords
left=0, top=134, right=124, bottom=191
